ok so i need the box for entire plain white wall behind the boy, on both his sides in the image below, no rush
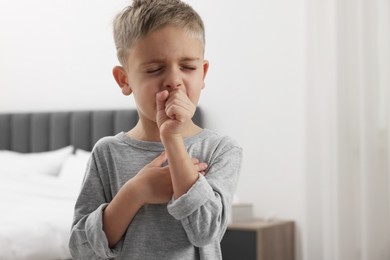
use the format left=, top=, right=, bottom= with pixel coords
left=0, top=0, right=306, bottom=260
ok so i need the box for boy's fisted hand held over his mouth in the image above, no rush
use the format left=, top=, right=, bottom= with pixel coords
left=156, top=89, right=196, bottom=136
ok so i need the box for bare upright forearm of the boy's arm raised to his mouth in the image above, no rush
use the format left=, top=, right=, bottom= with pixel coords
left=161, top=136, right=199, bottom=199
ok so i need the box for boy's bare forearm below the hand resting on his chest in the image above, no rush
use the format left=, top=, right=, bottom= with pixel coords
left=103, top=180, right=142, bottom=247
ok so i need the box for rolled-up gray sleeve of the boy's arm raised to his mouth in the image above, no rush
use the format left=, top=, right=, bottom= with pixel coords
left=168, top=146, right=242, bottom=247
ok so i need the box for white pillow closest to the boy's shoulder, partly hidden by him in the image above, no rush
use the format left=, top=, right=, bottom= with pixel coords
left=58, top=149, right=91, bottom=185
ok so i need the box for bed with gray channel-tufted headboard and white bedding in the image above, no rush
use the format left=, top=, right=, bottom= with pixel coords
left=0, top=108, right=203, bottom=260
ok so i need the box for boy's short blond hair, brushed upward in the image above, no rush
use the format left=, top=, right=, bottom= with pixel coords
left=113, top=0, right=205, bottom=66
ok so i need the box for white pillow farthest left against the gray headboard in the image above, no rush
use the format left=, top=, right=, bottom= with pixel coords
left=0, top=146, right=73, bottom=176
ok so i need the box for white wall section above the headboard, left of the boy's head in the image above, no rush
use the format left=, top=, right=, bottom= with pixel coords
left=0, top=0, right=132, bottom=111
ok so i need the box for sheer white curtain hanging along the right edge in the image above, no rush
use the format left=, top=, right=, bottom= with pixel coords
left=304, top=0, right=390, bottom=260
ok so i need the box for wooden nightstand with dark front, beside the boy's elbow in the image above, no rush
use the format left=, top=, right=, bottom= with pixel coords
left=221, top=219, right=294, bottom=260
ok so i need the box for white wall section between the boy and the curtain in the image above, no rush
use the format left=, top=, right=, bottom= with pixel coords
left=193, top=0, right=306, bottom=259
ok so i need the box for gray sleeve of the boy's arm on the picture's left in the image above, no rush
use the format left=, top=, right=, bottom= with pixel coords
left=69, top=155, right=122, bottom=259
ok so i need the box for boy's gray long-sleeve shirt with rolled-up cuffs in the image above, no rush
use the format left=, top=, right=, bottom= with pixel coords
left=69, top=129, right=242, bottom=260
